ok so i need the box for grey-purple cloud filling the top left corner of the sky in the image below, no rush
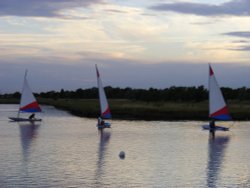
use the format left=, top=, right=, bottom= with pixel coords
left=0, top=0, right=103, bottom=17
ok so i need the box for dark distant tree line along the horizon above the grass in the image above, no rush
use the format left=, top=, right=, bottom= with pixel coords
left=0, top=86, right=250, bottom=102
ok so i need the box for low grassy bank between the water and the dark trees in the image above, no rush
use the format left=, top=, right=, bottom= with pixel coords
left=0, top=98, right=250, bottom=120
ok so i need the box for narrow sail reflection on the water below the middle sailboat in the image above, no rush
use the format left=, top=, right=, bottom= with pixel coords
left=96, top=130, right=111, bottom=187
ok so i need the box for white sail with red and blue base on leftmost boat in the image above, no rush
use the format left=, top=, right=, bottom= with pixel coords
left=19, top=71, right=41, bottom=112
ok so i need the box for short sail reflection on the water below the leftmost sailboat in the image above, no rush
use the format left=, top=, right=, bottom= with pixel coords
left=19, top=122, right=40, bottom=161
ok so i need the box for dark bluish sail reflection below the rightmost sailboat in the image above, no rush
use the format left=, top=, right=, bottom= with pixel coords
left=207, top=136, right=230, bottom=187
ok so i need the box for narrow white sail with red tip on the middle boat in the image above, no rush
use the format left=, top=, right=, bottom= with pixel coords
left=95, top=65, right=111, bottom=119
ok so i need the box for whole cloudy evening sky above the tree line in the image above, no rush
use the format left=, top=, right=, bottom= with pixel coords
left=0, top=0, right=250, bottom=93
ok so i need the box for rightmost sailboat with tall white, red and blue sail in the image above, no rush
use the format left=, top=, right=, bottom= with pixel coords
left=203, top=65, right=231, bottom=131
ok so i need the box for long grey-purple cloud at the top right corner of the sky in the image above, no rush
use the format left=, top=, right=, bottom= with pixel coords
left=150, top=0, right=250, bottom=16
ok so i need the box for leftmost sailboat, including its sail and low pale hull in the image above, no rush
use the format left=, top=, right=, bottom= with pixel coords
left=9, top=70, right=41, bottom=122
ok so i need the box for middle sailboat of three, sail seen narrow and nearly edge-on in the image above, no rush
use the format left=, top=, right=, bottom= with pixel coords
left=95, top=65, right=111, bottom=129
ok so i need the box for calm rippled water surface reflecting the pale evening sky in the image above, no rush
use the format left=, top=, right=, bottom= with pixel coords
left=0, top=105, right=250, bottom=188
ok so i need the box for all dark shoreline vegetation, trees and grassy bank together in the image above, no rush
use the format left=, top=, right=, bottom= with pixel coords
left=0, top=86, right=250, bottom=120
